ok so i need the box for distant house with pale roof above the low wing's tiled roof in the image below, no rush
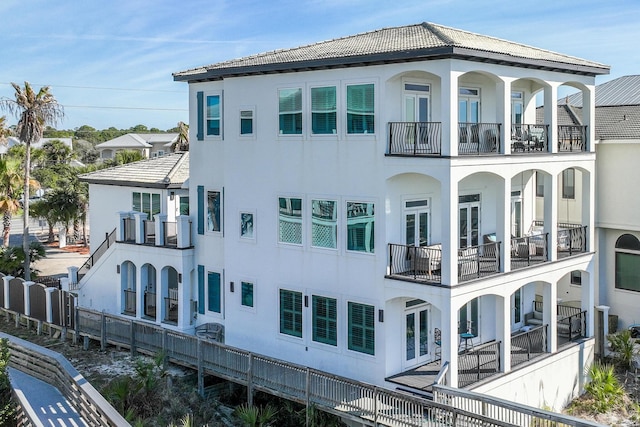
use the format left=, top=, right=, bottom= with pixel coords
left=96, top=133, right=178, bottom=160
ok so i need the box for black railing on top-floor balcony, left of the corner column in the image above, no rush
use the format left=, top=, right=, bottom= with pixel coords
left=388, top=122, right=442, bottom=156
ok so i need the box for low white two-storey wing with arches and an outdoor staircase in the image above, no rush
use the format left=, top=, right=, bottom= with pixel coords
left=76, top=152, right=193, bottom=330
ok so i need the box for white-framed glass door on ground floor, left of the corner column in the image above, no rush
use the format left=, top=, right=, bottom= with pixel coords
left=404, top=303, right=430, bottom=368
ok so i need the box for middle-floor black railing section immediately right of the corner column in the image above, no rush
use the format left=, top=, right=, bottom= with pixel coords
left=458, top=242, right=502, bottom=282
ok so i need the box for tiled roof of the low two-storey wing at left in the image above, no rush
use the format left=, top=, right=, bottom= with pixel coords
left=80, top=151, right=189, bottom=188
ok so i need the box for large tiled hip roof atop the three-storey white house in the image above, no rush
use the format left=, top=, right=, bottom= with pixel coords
left=173, top=22, right=609, bottom=81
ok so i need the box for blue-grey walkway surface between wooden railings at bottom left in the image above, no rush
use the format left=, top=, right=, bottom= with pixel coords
left=8, top=368, right=88, bottom=427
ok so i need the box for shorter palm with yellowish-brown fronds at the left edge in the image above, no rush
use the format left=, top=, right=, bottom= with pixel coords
left=0, top=158, right=22, bottom=248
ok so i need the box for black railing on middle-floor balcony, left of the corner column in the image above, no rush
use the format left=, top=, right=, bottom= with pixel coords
left=388, top=243, right=442, bottom=283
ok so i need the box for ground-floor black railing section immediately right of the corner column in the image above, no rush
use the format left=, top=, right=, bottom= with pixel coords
left=458, top=341, right=501, bottom=388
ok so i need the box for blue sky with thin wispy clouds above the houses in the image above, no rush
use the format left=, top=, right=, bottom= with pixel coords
left=0, top=0, right=640, bottom=130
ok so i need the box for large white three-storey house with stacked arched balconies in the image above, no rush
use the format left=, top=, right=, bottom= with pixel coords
left=79, top=23, right=609, bottom=408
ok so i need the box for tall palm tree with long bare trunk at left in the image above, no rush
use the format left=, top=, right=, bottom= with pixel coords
left=0, top=82, right=64, bottom=280
